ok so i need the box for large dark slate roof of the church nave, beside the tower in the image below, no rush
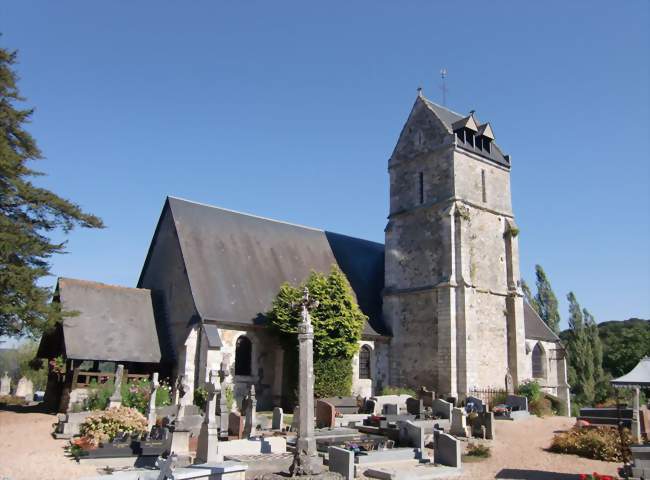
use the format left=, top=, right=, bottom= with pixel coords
left=163, top=197, right=389, bottom=335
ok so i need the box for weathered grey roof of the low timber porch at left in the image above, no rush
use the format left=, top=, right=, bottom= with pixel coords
left=39, top=278, right=161, bottom=363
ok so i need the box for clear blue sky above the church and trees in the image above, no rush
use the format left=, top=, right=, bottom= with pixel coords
left=0, top=0, right=650, bottom=325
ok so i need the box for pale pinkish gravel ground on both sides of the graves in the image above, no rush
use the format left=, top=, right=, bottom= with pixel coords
left=0, top=411, right=619, bottom=480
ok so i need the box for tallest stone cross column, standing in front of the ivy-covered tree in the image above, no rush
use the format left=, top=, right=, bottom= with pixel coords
left=289, top=287, right=322, bottom=476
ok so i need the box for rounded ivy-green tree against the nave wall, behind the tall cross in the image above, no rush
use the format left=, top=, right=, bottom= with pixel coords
left=267, top=265, right=367, bottom=397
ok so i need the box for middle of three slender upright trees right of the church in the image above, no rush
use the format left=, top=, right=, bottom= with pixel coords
left=566, top=292, right=595, bottom=405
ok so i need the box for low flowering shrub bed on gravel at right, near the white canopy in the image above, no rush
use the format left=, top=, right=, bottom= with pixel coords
left=550, top=427, right=631, bottom=462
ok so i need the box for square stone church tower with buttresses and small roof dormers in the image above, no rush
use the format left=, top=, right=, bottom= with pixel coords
left=383, top=92, right=530, bottom=397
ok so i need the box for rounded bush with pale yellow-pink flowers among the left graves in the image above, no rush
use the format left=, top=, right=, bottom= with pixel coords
left=79, top=407, right=147, bottom=446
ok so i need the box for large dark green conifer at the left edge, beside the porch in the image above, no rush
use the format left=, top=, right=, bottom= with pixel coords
left=0, top=44, right=103, bottom=336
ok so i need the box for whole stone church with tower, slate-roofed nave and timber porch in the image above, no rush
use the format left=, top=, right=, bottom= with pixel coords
left=39, top=91, right=569, bottom=409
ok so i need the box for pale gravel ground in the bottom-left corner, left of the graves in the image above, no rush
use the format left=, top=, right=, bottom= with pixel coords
left=0, top=410, right=97, bottom=480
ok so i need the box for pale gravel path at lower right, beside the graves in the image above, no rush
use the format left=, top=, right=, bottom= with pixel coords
left=440, top=417, right=620, bottom=480
